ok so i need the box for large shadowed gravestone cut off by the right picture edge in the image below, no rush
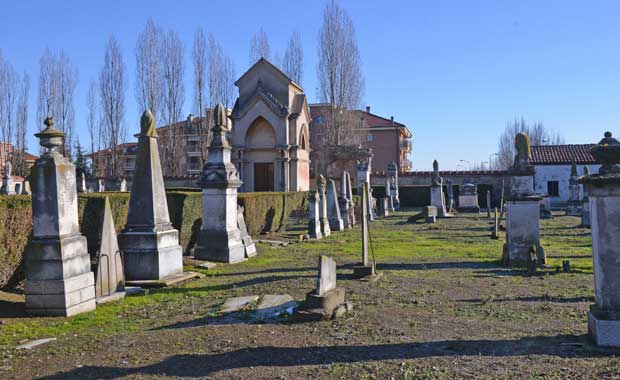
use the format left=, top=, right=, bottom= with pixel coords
left=580, top=132, right=620, bottom=347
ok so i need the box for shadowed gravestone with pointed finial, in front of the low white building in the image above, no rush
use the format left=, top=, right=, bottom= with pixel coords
left=502, top=133, right=546, bottom=265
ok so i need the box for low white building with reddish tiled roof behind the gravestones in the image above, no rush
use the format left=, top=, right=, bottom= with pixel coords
left=531, top=144, right=600, bottom=207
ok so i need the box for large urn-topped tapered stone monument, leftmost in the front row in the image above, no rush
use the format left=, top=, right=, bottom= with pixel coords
left=24, top=117, right=95, bottom=316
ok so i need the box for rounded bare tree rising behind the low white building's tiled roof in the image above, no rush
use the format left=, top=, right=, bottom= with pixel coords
left=490, top=117, right=564, bottom=169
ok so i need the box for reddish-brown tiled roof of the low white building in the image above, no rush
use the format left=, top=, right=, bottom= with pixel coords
left=532, top=144, right=596, bottom=165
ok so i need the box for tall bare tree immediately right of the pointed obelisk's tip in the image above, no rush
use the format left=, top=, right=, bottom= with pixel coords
left=161, top=30, right=185, bottom=176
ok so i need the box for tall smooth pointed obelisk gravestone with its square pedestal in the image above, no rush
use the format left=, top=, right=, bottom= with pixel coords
left=117, top=110, right=183, bottom=283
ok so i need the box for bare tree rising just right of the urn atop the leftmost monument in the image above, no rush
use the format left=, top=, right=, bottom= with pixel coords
left=53, top=50, right=78, bottom=158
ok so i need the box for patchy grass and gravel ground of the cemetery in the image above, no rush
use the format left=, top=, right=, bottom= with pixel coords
left=0, top=210, right=620, bottom=380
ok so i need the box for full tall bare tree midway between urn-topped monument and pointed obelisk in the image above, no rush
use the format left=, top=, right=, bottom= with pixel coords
left=99, top=37, right=125, bottom=176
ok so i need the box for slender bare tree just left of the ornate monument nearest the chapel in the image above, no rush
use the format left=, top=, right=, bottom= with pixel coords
left=192, top=28, right=209, bottom=166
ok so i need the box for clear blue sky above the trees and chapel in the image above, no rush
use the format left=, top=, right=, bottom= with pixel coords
left=0, top=0, right=620, bottom=170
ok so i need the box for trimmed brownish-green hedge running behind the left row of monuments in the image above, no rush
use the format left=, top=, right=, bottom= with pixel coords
left=0, top=191, right=308, bottom=288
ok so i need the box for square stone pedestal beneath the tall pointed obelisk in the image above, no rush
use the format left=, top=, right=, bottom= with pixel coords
left=118, top=229, right=183, bottom=282
